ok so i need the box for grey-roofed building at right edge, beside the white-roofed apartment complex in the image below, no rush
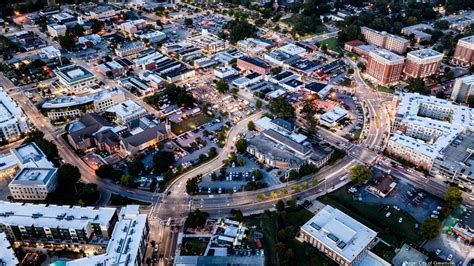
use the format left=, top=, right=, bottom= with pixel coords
left=430, top=131, right=474, bottom=190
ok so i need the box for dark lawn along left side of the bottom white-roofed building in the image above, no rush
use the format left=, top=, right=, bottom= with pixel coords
left=246, top=208, right=337, bottom=266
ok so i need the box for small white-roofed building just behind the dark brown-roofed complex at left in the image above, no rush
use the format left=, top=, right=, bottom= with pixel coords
left=105, top=100, right=148, bottom=125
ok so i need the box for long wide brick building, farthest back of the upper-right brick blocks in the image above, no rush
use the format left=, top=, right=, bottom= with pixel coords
left=360, top=27, right=410, bottom=54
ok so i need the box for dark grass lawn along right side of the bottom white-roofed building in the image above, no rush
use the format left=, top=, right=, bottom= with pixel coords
left=319, top=184, right=423, bottom=247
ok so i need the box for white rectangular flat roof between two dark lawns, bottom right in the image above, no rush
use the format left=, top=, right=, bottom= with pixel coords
left=301, top=205, right=377, bottom=262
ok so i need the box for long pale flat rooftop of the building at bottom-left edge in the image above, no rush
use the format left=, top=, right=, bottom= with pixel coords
left=0, top=201, right=116, bottom=229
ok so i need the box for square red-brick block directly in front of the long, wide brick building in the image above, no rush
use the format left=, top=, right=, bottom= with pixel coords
left=366, top=49, right=405, bottom=85
